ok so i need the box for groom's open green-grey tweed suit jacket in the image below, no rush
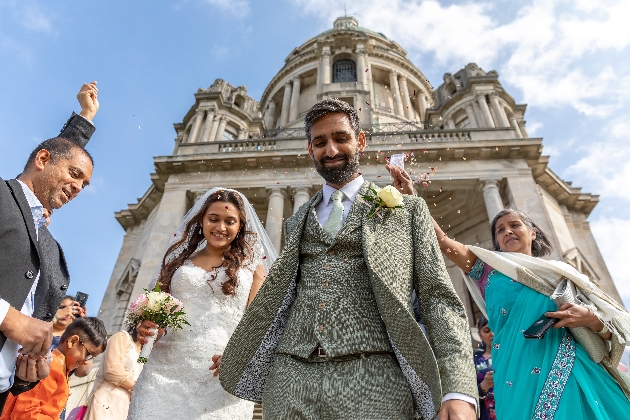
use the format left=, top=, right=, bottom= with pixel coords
left=219, top=182, right=478, bottom=419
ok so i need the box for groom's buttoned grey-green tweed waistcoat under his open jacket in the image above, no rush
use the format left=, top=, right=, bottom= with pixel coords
left=276, top=199, right=392, bottom=358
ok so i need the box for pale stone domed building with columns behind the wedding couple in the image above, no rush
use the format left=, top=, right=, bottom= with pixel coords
left=99, top=17, right=620, bottom=342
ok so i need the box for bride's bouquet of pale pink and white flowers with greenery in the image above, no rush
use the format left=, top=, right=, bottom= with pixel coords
left=125, top=284, right=190, bottom=363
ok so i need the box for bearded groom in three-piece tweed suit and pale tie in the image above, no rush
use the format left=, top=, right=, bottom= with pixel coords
left=220, top=99, right=477, bottom=420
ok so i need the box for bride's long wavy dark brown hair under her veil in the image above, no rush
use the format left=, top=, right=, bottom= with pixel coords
left=158, top=190, right=256, bottom=296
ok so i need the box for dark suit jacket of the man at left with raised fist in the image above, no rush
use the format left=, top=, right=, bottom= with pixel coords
left=0, top=113, right=95, bottom=348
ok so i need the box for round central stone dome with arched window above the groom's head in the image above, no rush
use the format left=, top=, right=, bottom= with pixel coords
left=261, top=17, right=433, bottom=131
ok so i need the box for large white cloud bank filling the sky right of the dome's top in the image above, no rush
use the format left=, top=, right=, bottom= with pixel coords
left=294, top=0, right=630, bottom=116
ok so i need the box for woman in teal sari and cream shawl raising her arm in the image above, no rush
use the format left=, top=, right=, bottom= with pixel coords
left=387, top=166, right=630, bottom=420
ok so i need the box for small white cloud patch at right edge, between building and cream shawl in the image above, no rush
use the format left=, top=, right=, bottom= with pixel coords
left=591, top=217, right=630, bottom=308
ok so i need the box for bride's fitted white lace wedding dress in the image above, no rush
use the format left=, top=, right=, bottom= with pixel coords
left=128, top=260, right=256, bottom=420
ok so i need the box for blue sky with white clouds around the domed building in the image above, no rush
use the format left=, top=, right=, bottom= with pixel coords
left=0, top=0, right=630, bottom=314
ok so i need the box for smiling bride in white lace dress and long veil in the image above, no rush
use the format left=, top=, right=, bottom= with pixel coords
left=128, top=188, right=276, bottom=420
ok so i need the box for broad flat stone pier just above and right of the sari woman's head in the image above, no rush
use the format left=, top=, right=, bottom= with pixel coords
left=507, top=173, right=562, bottom=261
